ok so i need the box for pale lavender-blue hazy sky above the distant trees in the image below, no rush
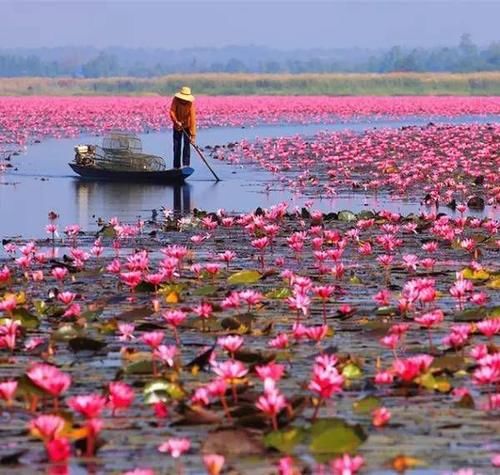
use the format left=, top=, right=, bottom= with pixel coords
left=0, top=0, right=500, bottom=49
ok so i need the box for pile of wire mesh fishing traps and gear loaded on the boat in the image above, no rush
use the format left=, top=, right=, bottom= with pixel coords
left=75, top=132, right=166, bottom=172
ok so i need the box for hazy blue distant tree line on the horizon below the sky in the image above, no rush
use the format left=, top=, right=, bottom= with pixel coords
left=0, top=34, right=500, bottom=78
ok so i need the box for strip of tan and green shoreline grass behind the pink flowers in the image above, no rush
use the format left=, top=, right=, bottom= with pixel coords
left=0, top=72, right=500, bottom=96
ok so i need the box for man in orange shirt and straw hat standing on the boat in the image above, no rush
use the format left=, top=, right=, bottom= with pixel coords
left=170, top=86, right=196, bottom=168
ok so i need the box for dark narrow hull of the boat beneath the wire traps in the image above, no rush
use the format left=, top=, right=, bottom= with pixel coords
left=68, top=163, right=194, bottom=183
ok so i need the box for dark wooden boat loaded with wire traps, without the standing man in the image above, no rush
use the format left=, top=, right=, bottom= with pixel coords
left=68, top=132, right=194, bottom=184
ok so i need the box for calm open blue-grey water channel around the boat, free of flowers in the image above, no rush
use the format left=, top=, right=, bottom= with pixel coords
left=0, top=116, right=498, bottom=238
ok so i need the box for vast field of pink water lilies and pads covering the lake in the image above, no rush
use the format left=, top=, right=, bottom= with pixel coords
left=0, top=97, right=500, bottom=475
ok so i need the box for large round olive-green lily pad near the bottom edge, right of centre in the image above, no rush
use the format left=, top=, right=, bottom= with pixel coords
left=310, top=418, right=367, bottom=454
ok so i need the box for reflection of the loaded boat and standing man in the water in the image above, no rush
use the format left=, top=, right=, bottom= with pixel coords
left=73, top=179, right=191, bottom=229
